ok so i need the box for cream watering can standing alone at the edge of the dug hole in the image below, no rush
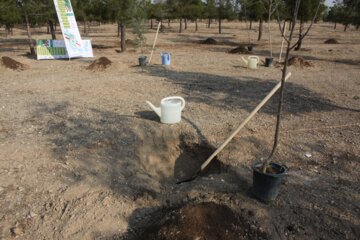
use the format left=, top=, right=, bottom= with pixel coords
left=146, top=96, right=185, bottom=124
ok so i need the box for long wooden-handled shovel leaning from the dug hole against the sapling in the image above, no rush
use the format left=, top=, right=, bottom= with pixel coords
left=176, top=72, right=291, bottom=184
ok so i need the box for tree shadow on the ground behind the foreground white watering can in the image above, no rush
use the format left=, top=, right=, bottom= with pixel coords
left=145, top=66, right=360, bottom=115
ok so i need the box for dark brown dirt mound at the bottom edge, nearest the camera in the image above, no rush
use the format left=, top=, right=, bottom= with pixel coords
left=139, top=203, right=268, bottom=240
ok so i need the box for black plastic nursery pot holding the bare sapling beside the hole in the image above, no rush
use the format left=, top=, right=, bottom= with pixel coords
left=252, top=163, right=287, bottom=202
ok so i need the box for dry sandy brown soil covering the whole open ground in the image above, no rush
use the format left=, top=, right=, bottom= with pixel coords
left=0, top=23, right=360, bottom=239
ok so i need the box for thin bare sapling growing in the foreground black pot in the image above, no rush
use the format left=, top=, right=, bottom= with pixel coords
left=260, top=0, right=321, bottom=173
